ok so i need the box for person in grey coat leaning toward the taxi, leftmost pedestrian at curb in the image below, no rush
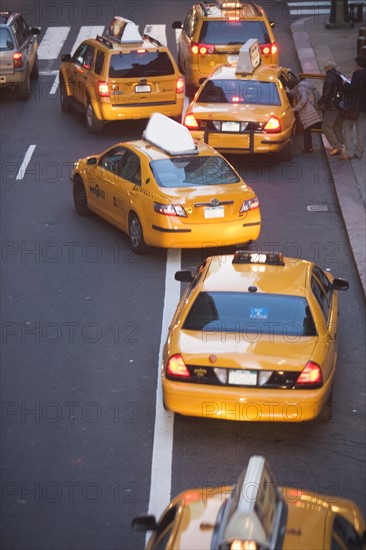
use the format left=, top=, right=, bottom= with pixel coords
left=288, top=79, right=323, bottom=153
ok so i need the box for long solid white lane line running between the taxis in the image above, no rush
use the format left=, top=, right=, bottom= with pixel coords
left=149, top=249, right=181, bottom=517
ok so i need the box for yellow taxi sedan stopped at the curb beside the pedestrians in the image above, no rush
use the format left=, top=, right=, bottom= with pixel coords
left=184, top=40, right=296, bottom=160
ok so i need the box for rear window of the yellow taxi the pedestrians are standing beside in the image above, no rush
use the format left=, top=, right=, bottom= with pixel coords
left=196, top=79, right=281, bottom=106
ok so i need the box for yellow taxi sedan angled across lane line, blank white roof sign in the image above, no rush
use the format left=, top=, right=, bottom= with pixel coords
left=72, top=113, right=261, bottom=253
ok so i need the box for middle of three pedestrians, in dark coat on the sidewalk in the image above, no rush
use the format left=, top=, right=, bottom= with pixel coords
left=318, top=61, right=343, bottom=155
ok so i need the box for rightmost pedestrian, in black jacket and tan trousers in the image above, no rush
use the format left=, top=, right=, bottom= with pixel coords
left=339, top=57, right=366, bottom=160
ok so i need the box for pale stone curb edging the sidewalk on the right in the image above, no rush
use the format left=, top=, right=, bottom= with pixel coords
left=290, top=17, right=366, bottom=298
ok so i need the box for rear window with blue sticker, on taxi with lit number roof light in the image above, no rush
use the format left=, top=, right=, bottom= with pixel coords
left=183, top=292, right=317, bottom=336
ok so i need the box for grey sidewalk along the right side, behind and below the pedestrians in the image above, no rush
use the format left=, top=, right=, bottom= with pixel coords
left=291, top=14, right=366, bottom=296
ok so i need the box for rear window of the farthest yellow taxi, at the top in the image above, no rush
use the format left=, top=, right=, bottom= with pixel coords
left=199, top=20, right=271, bottom=46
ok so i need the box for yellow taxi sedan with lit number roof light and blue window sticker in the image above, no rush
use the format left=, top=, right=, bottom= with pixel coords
left=162, top=250, right=348, bottom=422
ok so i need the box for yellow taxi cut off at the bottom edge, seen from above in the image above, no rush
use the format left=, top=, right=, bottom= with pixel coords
left=132, top=456, right=366, bottom=550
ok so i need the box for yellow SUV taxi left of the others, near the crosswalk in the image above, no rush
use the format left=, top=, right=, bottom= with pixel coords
left=60, top=16, right=184, bottom=134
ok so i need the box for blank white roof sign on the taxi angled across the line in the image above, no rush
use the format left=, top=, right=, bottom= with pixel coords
left=142, top=113, right=198, bottom=155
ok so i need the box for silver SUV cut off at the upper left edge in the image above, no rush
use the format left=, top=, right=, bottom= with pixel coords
left=0, top=11, right=40, bottom=100
